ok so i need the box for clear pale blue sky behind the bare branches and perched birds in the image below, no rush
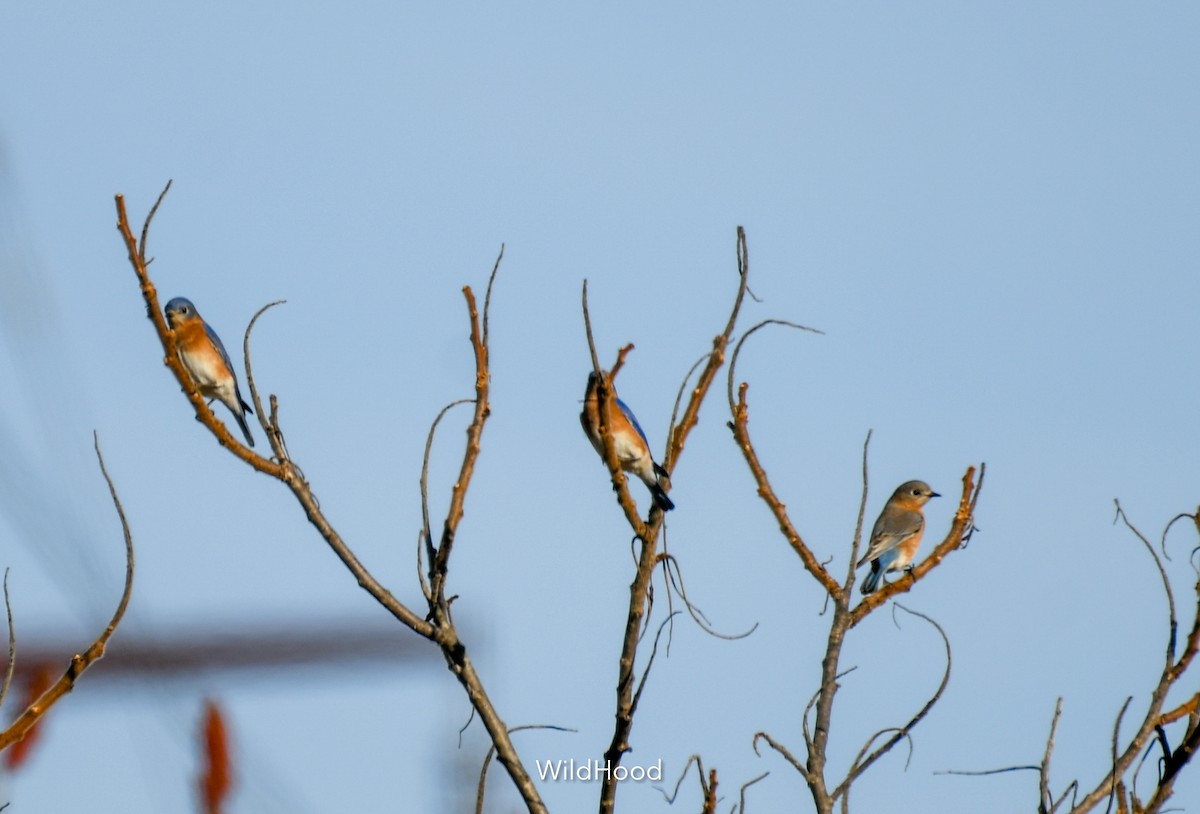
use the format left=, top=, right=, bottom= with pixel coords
left=0, top=0, right=1200, bottom=814
